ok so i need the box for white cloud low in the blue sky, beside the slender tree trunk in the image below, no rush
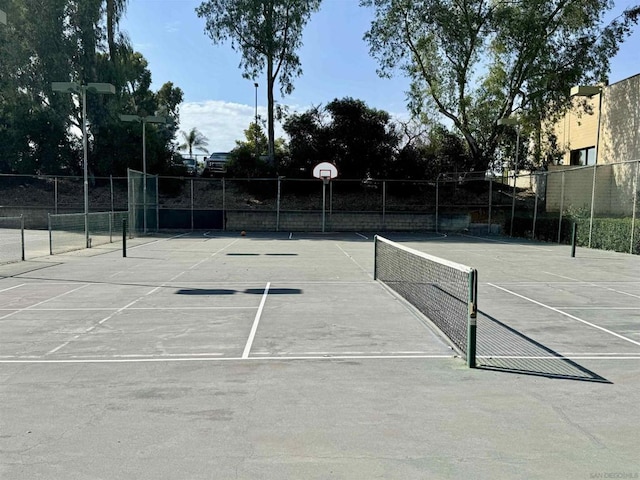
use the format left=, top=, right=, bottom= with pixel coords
left=178, top=100, right=285, bottom=152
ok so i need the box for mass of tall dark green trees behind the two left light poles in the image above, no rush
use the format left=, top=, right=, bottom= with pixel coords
left=0, top=0, right=182, bottom=176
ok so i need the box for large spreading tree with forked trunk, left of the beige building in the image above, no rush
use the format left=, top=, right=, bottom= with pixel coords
left=361, top=0, right=640, bottom=170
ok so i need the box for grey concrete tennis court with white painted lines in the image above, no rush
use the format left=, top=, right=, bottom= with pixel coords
left=0, top=232, right=640, bottom=479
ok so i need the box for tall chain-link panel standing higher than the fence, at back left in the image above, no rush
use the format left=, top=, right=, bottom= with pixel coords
left=127, top=168, right=159, bottom=235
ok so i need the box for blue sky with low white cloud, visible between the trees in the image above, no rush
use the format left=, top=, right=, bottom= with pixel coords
left=120, top=0, right=640, bottom=152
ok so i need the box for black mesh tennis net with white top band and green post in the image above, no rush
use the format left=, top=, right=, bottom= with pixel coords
left=374, top=236, right=478, bottom=367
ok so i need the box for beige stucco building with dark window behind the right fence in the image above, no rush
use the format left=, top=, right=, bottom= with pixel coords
left=546, top=74, right=640, bottom=216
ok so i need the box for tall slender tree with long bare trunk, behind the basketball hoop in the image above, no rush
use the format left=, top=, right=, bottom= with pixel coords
left=196, top=0, right=321, bottom=171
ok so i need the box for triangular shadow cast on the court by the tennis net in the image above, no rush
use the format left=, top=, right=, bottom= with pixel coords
left=477, top=311, right=613, bottom=384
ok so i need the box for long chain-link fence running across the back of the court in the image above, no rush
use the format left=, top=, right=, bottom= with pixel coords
left=0, top=160, right=640, bottom=253
